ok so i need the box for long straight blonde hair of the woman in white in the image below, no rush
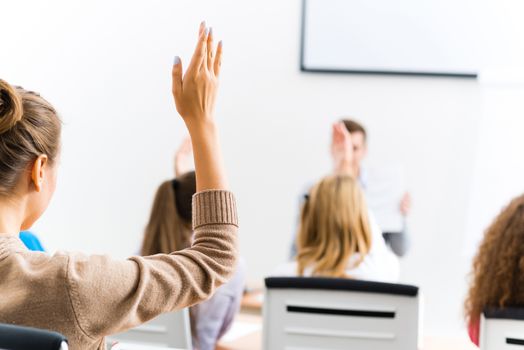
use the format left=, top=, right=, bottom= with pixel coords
left=297, top=175, right=372, bottom=277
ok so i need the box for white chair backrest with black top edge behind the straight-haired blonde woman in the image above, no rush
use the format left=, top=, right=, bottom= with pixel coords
left=263, top=277, right=421, bottom=350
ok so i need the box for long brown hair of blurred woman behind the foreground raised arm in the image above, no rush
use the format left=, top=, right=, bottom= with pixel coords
left=141, top=172, right=196, bottom=255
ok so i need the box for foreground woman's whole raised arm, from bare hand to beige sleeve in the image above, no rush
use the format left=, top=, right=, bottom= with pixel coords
left=57, top=22, right=238, bottom=342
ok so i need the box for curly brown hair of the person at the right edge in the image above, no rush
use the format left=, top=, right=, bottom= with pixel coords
left=465, top=195, right=524, bottom=346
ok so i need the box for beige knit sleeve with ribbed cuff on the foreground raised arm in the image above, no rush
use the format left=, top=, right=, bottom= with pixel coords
left=66, top=190, right=238, bottom=339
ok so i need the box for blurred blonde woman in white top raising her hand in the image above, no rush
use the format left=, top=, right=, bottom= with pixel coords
left=273, top=123, right=399, bottom=282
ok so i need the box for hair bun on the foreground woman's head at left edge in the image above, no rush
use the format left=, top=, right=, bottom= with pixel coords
left=0, top=79, right=24, bottom=134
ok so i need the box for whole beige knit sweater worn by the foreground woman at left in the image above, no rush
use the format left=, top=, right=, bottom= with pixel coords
left=0, top=191, right=238, bottom=350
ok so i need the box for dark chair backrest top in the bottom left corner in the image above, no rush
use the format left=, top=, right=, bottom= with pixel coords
left=0, top=324, right=68, bottom=350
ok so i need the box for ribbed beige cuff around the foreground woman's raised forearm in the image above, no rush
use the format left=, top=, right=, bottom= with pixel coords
left=193, top=190, right=238, bottom=229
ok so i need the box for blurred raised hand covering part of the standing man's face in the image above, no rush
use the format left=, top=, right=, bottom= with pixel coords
left=331, top=122, right=357, bottom=176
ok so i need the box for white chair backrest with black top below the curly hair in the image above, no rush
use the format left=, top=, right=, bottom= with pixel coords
left=480, top=308, right=524, bottom=350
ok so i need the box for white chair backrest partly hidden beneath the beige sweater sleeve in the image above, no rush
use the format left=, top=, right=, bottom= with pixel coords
left=108, top=308, right=193, bottom=349
